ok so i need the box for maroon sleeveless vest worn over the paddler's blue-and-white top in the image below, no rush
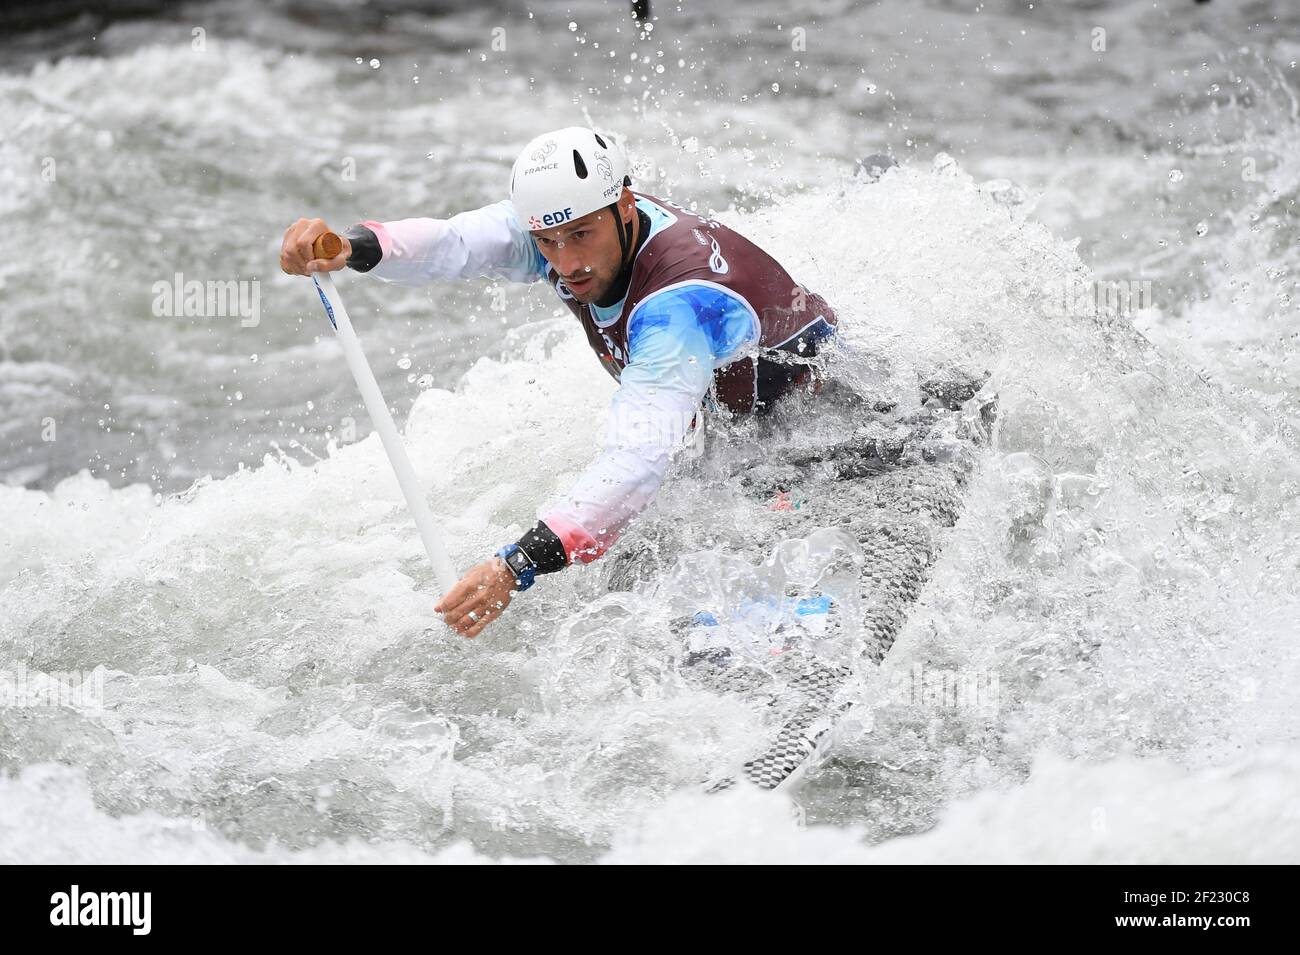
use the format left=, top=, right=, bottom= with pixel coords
left=546, top=192, right=836, bottom=413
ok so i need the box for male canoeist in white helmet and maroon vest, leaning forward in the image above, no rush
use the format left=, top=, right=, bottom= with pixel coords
left=280, top=126, right=836, bottom=637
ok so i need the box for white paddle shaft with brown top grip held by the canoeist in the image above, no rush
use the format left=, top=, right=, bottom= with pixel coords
left=312, top=233, right=456, bottom=594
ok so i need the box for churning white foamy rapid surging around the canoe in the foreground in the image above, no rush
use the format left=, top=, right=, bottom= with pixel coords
left=0, top=156, right=1300, bottom=861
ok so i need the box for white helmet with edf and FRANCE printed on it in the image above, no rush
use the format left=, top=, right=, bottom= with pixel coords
left=510, top=126, right=628, bottom=231
